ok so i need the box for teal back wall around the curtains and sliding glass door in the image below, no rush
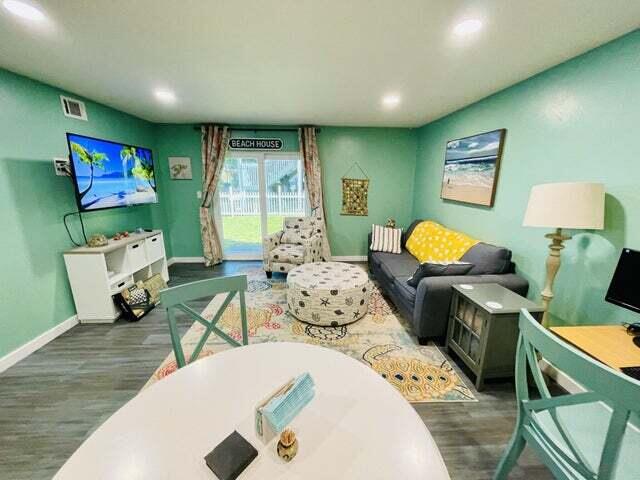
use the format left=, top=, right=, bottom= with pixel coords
left=156, top=125, right=416, bottom=257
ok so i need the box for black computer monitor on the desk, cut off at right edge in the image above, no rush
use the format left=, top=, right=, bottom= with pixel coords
left=605, top=248, right=640, bottom=347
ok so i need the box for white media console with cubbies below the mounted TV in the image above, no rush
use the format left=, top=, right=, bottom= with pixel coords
left=64, top=230, right=169, bottom=323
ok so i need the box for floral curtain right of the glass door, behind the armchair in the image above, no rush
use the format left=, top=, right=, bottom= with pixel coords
left=298, top=127, right=331, bottom=262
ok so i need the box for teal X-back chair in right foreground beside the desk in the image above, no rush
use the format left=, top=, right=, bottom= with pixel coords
left=494, top=310, right=640, bottom=480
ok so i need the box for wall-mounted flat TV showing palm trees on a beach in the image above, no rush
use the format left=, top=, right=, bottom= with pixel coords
left=67, top=133, right=158, bottom=211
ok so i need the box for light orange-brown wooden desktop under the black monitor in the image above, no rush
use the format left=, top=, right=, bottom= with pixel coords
left=549, top=325, right=640, bottom=370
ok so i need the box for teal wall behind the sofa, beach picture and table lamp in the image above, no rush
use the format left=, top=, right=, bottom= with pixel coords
left=413, top=31, right=640, bottom=324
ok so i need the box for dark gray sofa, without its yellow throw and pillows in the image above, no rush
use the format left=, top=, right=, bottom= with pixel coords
left=368, top=220, right=529, bottom=344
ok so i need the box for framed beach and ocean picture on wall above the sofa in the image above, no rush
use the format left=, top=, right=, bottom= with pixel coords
left=440, top=128, right=507, bottom=207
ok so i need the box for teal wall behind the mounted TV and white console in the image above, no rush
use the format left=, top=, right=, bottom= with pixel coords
left=0, top=69, right=164, bottom=357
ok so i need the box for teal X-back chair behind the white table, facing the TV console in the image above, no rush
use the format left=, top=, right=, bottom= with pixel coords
left=160, top=275, right=249, bottom=368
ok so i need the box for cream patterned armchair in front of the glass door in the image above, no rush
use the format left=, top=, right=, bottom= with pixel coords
left=262, top=217, right=323, bottom=278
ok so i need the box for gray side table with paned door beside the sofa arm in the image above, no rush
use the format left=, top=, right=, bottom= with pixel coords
left=446, top=283, right=544, bottom=391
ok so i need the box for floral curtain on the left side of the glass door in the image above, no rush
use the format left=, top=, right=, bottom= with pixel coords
left=200, top=125, right=230, bottom=267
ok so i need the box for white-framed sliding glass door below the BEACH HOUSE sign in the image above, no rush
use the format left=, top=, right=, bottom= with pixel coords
left=216, top=152, right=308, bottom=260
